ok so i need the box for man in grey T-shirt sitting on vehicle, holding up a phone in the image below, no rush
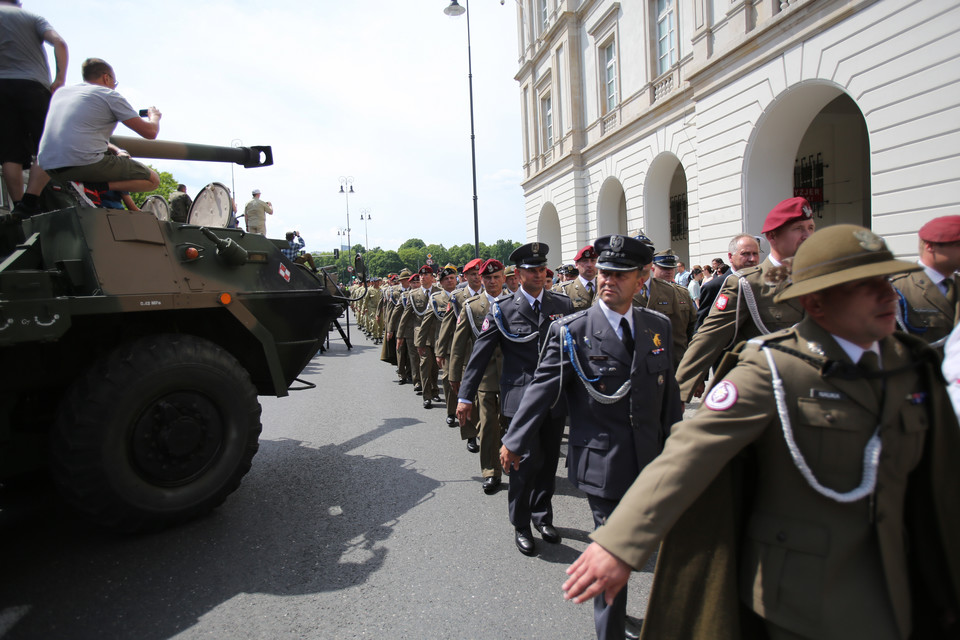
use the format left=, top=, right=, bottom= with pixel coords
left=38, top=58, right=161, bottom=202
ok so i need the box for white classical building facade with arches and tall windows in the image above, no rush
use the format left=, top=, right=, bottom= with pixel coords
left=516, top=0, right=960, bottom=264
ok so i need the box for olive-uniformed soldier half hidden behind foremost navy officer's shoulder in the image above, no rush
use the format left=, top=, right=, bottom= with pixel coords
left=633, top=249, right=697, bottom=368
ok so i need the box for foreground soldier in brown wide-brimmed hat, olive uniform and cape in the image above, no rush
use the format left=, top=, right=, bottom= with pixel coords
left=564, top=225, right=960, bottom=640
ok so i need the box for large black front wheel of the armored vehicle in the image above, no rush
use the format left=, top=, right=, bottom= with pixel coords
left=51, top=334, right=260, bottom=531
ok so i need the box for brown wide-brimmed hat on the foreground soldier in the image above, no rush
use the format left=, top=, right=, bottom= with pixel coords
left=774, top=224, right=923, bottom=302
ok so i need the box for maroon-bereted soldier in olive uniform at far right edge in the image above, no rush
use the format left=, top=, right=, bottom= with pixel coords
left=893, top=216, right=960, bottom=353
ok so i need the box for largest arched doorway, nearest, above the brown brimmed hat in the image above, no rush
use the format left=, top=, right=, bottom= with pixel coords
left=742, top=80, right=871, bottom=233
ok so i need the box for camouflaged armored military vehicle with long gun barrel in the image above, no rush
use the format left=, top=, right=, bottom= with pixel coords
left=0, top=138, right=363, bottom=531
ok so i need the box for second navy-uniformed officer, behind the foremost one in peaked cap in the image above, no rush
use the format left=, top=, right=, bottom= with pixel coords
left=457, top=242, right=573, bottom=555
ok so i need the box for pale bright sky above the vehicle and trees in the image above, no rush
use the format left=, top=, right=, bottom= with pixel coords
left=23, top=0, right=526, bottom=251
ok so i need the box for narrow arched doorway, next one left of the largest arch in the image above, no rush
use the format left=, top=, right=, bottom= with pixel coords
left=643, top=153, right=690, bottom=265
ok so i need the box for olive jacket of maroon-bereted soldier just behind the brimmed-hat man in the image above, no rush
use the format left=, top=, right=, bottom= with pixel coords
left=674, top=258, right=803, bottom=402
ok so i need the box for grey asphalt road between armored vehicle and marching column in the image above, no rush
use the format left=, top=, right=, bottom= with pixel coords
left=0, top=318, right=652, bottom=640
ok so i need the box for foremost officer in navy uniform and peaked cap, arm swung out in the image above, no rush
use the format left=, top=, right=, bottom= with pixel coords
left=500, top=235, right=683, bottom=640
